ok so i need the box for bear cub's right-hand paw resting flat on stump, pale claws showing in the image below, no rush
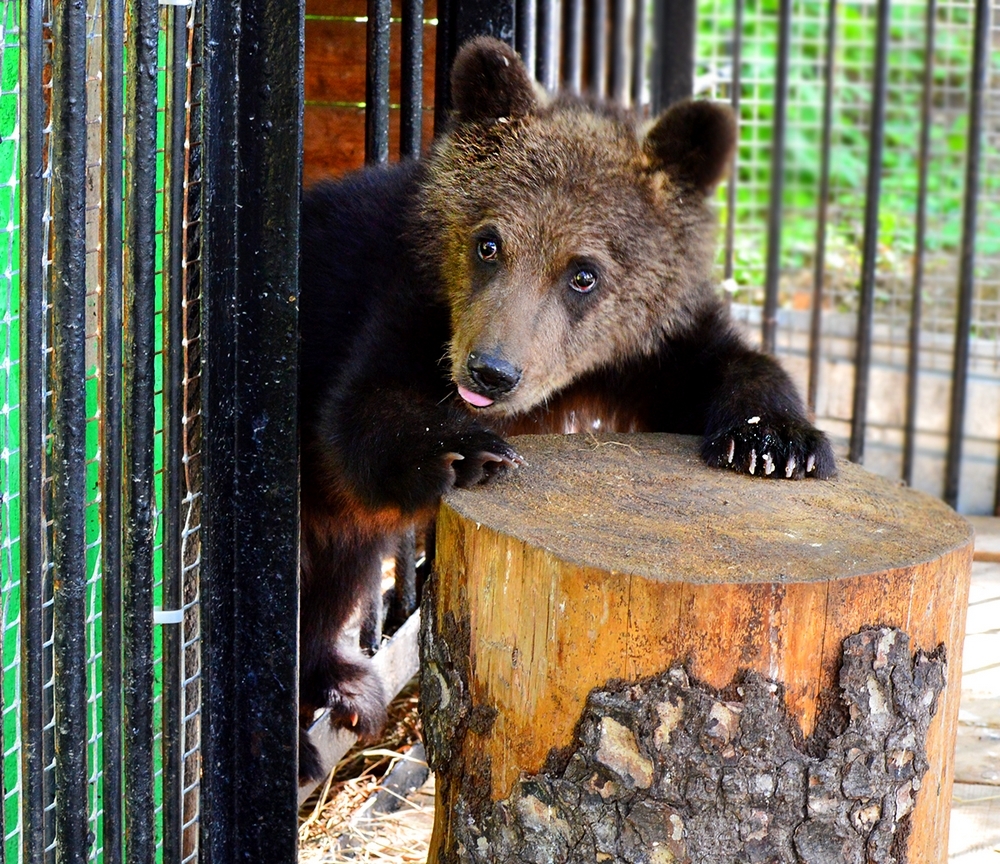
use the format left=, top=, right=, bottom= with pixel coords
left=701, top=416, right=837, bottom=480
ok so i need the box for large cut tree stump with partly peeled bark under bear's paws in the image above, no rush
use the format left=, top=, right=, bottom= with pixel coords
left=421, top=435, right=972, bottom=864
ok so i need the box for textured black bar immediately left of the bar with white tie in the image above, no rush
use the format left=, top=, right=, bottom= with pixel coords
left=122, top=0, right=159, bottom=864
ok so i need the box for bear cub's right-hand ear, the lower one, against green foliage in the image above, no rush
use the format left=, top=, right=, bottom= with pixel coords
left=642, top=100, right=736, bottom=195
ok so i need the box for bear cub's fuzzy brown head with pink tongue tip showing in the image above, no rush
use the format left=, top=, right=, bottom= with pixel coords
left=422, top=38, right=736, bottom=416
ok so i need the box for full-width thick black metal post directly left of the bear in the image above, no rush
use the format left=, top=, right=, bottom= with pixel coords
left=200, top=0, right=304, bottom=864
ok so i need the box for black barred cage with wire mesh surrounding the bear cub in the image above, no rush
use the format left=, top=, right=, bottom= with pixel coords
left=0, top=0, right=1000, bottom=864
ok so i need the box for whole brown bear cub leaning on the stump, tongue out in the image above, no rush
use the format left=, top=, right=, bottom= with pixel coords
left=300, top=39, right=835, bottom=777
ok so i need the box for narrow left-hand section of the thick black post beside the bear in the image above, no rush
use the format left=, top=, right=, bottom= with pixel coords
left=198, top=2, right=241, bottom=852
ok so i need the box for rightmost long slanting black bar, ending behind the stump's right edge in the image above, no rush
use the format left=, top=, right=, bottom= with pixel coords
left=944, top=0, right=991, bottom=507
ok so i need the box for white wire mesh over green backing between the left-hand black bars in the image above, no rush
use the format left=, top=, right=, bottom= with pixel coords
left=0, top=0, right=201, bottom=862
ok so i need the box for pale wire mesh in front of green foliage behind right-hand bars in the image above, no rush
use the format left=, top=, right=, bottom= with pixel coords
left=696, top=0, right=1000, bottom=368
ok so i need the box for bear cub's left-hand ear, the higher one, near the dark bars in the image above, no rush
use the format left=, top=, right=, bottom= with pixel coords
left=451, top=36, right=535, bottom=122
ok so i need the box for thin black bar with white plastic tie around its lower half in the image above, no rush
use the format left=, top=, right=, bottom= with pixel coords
left=160, top=6, right=188, bottom=862
